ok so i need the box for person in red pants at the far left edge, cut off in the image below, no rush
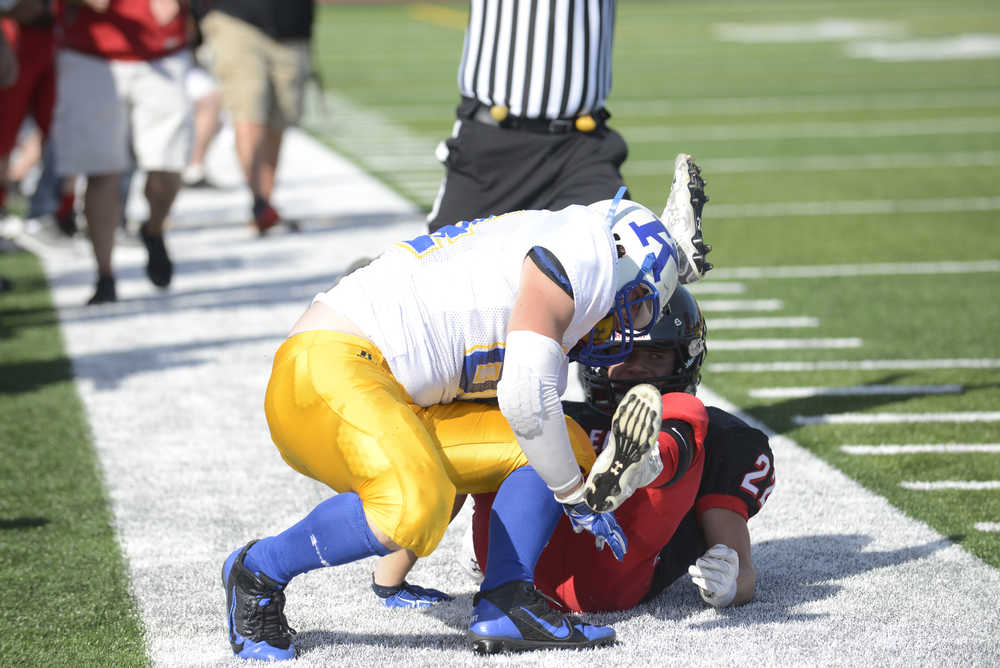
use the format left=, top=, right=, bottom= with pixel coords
left=0, top=0, right=55, bottom=222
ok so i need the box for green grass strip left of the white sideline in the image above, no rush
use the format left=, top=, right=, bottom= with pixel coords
left=0, top=252, right=147, bottom=666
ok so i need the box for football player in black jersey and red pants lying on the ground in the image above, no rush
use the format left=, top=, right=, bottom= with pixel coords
left=464, top=286, right=775, bottom=611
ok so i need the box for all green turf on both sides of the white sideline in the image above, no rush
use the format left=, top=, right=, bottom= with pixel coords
left=0, top=0, right=1000, bottom=666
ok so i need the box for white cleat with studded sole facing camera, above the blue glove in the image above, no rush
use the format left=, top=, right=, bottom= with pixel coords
left=583, top=383, right=663, bottom=513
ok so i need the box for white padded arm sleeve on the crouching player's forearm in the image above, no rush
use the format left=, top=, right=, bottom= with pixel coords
left=497, top=330, right=582, bottom=496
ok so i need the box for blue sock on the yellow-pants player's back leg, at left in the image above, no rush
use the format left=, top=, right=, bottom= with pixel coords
left=243, top=492, right=389, bottom=583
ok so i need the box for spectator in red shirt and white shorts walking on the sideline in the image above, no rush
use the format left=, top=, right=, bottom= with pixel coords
left=53, top=0, right=192, bottom=304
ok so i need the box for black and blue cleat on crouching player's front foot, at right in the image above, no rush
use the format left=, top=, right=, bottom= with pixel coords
left=468, top=580, right=615, bottom=654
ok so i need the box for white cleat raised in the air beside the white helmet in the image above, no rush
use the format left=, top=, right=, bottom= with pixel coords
left=660, top=153, right=712, bottom=284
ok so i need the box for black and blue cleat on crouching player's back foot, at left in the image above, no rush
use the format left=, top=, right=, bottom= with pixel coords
left=222, top=541, right=295, bottom=661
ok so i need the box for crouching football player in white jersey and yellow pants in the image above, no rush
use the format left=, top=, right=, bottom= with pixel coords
left=222, top=154, right=711, bottom=660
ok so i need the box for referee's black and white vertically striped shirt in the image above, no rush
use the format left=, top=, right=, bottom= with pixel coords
left=458, top=0, right=615, bottom=118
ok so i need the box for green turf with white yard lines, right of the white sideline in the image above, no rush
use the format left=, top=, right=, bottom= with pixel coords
left=306, top=1, right=1000, bottom=566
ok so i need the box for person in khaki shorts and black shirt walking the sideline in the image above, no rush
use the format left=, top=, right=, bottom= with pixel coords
left=200, top=0, right=314, bottom=234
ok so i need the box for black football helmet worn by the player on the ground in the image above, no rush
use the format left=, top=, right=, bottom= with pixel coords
left=580, top=285, right=707, bottom=414
